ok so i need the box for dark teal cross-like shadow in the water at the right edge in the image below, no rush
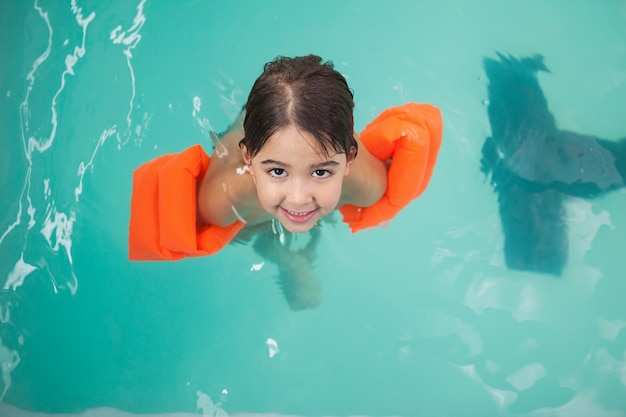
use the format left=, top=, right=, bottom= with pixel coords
left=481, top=54, right=626, bottom=275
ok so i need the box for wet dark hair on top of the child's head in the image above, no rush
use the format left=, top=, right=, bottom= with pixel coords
left=242, top=55, right=358, bottom=156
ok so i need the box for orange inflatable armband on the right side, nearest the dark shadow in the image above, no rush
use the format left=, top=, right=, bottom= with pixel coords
left=339, top=103, right=443, bottom=233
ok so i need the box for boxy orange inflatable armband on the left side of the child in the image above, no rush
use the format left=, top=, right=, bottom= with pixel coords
left=128, top=145, right=244, bottom=261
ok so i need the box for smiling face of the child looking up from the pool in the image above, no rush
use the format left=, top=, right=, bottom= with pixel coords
left=242, top=125, right=353, bottom=232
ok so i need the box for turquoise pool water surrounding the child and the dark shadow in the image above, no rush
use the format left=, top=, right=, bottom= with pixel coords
left=0, top=0, right=626, bottom=417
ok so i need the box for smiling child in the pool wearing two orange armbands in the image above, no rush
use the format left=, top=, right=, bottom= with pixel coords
left=129, top=55, right=441, bottom=309
